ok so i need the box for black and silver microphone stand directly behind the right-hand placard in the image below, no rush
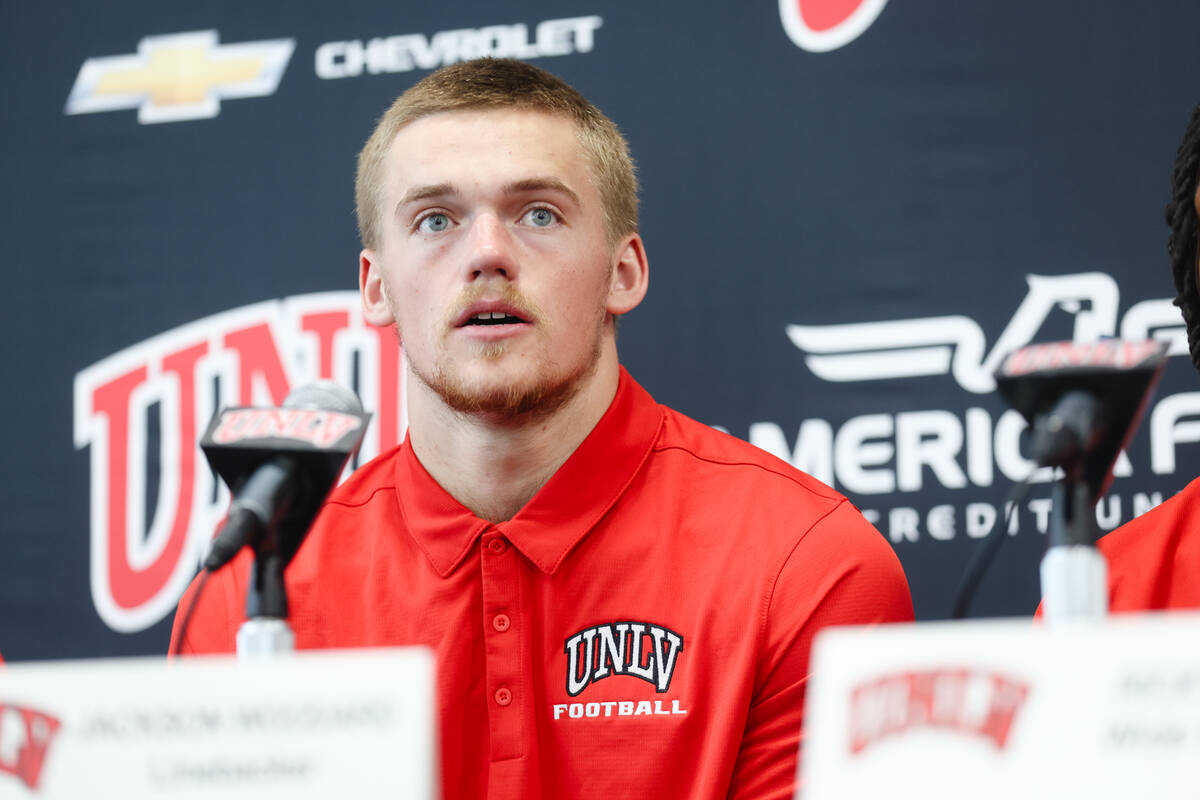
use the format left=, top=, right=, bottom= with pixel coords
left=1040, top=465, right=1109, bottom=625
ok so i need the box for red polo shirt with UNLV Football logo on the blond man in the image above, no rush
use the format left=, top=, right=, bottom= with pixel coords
left=173, top=371, right=912, bottom=800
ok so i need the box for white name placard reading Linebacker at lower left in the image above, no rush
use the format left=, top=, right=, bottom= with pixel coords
left=0, top=648, right=437, bottom=800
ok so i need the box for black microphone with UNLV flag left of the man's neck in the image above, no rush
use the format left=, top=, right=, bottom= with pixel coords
left=200, top=380, right=371, bottom=572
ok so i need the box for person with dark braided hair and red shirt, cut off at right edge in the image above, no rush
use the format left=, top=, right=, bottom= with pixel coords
left=1099, top=106, right=1200, bottom=612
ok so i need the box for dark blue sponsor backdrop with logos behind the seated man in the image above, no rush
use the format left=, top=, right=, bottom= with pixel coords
left=0, top=0, right=1200, bottom=660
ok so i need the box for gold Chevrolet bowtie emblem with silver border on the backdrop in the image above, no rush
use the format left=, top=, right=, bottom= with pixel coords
left=65, top=30, right=295, bottom=124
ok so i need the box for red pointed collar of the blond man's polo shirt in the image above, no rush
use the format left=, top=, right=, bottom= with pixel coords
left=396, top=367, right=664, bottom=577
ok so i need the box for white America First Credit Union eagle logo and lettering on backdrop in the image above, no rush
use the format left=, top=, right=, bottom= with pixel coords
left=746, top=272, right=1200, bottom=543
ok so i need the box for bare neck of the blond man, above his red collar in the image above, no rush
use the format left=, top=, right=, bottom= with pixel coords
left=408, top=348, right=619, bottom=523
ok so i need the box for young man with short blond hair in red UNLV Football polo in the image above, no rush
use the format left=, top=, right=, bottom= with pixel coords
left=176, top=60, right=912, bottom=799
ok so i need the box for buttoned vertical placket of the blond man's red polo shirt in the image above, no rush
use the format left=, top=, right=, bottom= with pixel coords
left=480, top=528, right=530, bottom=763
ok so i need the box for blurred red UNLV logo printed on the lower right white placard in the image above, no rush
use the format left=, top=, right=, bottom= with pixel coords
left=850, top=669, right=1030, bottom=754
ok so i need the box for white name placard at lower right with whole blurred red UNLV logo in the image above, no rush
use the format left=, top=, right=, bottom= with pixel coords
left=798, top=613, right=1200, bottom=800
